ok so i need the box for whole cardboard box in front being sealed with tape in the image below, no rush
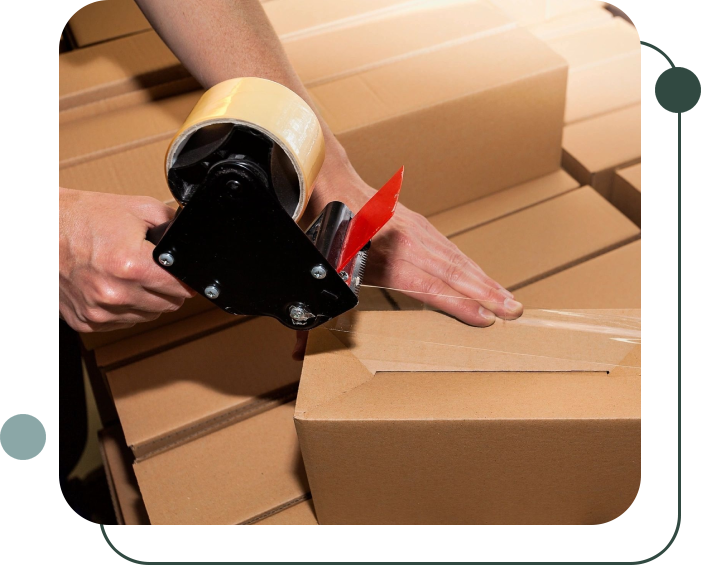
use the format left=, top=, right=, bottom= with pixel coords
left=295, top=311, right=641, bottom=525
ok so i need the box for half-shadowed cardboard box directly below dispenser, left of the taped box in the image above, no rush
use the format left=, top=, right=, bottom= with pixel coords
left=107, top=318, right=301, bottom=459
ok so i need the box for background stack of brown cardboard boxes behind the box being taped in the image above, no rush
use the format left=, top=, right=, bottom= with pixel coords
left=59, top=0, right=641, bottom=525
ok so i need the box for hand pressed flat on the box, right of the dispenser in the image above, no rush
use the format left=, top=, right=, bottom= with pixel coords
left=311, top=155, right=523, bottom=327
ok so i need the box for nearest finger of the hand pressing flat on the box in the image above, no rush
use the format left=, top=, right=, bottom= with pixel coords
left=398, top=262, right=504, bottom=328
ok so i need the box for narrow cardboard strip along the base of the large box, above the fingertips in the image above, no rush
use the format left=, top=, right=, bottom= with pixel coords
left=428, top=170, right=580, bottom=237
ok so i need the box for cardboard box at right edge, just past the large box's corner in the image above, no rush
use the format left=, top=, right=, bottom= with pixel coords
left=562, top=104, right=642, bottom=200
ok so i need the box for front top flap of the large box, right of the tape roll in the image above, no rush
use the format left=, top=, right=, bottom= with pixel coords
left=310, top=25, right=566, bottom=135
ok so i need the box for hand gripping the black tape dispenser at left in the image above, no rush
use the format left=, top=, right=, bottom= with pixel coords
left=58, top=188, right=195, bottom=332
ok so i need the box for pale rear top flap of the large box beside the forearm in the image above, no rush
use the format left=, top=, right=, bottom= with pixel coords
left=285, top=2, right=516, bottom=87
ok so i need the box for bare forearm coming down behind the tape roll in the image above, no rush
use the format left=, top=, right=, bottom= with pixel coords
left=132, top=0, right=368, bottom=211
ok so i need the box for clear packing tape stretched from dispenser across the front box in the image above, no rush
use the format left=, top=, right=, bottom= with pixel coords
left=323, top=286, right=642, bottom=375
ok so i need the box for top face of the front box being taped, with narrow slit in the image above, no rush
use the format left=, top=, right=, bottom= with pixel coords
left=296, top=310, right=641, bottom=421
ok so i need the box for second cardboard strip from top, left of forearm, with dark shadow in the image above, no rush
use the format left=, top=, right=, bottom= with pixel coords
left=58, top=32, right=189, bottom=112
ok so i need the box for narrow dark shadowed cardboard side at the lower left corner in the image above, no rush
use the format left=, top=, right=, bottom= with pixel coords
left=99, top=427, right=149, bottom=526
